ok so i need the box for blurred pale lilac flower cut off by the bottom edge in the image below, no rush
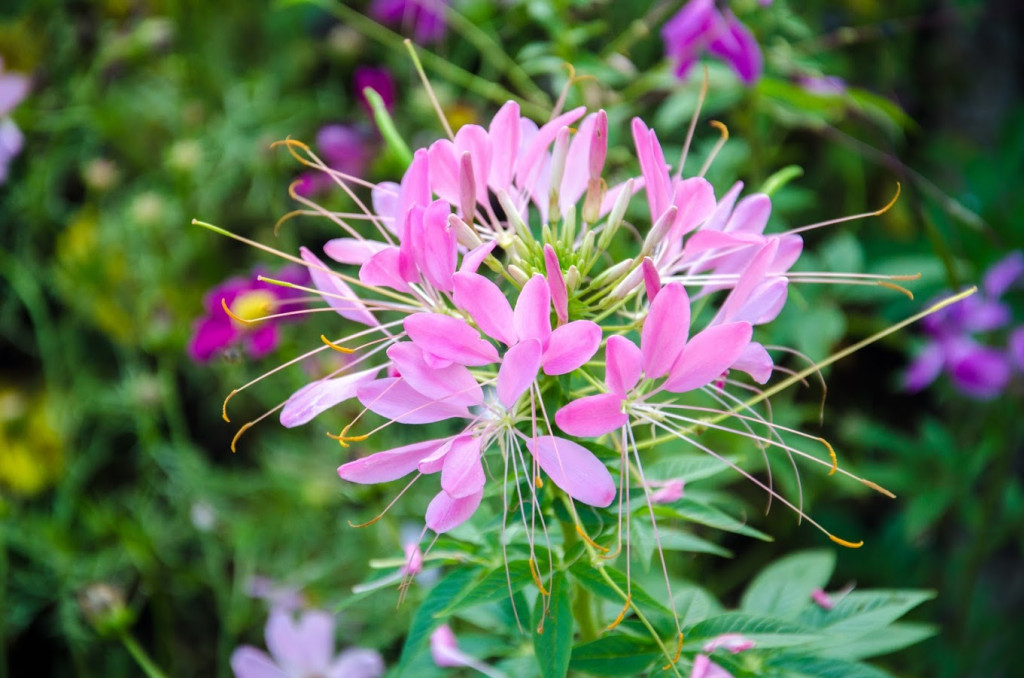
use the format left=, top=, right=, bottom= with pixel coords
left=231, top=609, right=384, bottom=678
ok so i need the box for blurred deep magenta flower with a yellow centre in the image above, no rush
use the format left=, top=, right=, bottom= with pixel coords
left=188, top=266, right=309, bottom=363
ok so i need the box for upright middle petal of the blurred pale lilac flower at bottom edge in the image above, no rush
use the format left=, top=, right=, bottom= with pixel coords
left=266, top=609, right=334, bottom=674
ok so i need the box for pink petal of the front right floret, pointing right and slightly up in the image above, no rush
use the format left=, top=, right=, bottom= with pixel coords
left=665, top=323, right=754, bottom=393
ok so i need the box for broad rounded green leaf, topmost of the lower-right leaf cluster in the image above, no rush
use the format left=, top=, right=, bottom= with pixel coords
left=739, top=550, right=836, bottom=619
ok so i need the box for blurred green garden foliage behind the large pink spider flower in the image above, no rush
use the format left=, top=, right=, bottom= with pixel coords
left=0, top=0, right=1024, bottom=677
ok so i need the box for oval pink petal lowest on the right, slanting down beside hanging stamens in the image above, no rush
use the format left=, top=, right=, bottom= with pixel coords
left=526, top=435, right=615, bottom=507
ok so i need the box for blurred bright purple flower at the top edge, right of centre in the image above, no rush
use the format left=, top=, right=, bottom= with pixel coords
left=662, top=0, right=764, bottom=85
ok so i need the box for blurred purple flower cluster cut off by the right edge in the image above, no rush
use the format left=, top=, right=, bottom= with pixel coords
left=903, top=251, right=1024, bottom=399
